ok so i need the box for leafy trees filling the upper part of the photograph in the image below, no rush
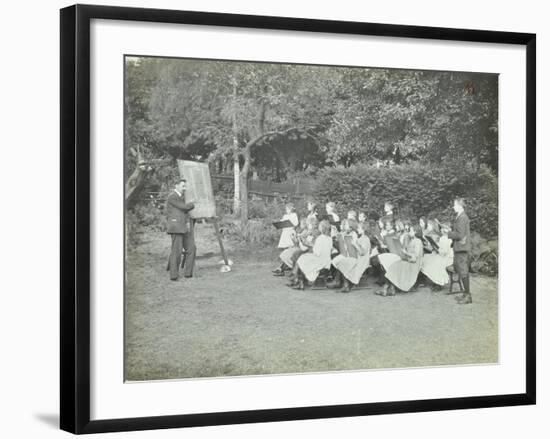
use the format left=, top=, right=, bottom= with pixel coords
left=125, top=58, right=498, bottom=225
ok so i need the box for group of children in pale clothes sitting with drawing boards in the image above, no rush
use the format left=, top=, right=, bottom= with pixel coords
left=273, top=201, right=453, bottom=296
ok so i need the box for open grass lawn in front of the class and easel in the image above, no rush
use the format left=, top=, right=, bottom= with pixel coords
left=125, top=225, right=498, bottom=381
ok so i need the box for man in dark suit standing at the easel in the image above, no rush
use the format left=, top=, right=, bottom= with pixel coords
left=165, top=179, right=196, bottom=280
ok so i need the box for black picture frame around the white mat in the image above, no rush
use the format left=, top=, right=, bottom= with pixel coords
left=60, top=5, right=536, bottom=434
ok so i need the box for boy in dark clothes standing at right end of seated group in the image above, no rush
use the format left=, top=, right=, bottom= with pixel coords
left=448, top=198, right=472, bottom=305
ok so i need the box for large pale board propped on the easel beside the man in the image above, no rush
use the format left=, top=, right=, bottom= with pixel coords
left=178, top=160, right=216, bottom=218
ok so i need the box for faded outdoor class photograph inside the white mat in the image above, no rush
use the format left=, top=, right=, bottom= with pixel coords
left=121, top=54, right=500, bottom=382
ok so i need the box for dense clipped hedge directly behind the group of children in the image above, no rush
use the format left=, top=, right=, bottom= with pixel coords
left=316, top=163, right=498, bottom=238
